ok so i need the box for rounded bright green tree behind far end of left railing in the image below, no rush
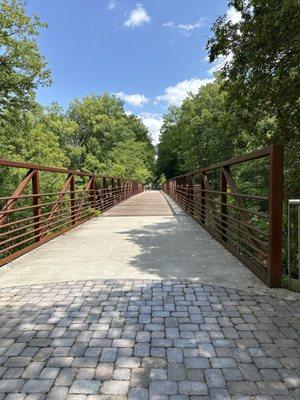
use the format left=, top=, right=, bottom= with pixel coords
left=62, top=93, right=154, bottom=177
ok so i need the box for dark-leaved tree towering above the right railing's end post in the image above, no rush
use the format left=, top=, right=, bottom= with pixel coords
left=207, top=0, right=300, bottom=196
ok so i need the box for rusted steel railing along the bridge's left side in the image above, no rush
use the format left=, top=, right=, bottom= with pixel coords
left=0, top=159, right=144, bottom=266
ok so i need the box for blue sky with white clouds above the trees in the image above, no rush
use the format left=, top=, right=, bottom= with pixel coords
left=27, top=0, right=234, bottom=143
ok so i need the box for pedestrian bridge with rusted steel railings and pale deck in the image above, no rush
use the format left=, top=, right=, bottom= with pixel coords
left=0, top=145, right=283, bottom=288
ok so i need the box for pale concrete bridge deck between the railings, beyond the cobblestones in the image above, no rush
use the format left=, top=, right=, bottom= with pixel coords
left=0, top=192, right=266, bottom=291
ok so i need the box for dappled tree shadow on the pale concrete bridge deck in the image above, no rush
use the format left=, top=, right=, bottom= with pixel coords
left=118, top=214, right=264, bottom=288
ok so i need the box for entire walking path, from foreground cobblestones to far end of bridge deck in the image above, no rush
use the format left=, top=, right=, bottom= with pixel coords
left=0, top=192, right=300, bottom=400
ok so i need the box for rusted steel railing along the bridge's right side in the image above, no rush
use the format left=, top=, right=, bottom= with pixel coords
left=164, top=145, right=283, bottom=287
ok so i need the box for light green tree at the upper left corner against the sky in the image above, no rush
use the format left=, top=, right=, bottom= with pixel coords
left=0, top=0, right=50, bottom=120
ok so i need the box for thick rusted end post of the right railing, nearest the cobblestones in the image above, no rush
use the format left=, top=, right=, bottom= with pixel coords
left=268, top=145, right=283, bottom=287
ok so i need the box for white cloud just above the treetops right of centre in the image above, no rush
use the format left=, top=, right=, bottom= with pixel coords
left=156, top=78, right=213, bottom=106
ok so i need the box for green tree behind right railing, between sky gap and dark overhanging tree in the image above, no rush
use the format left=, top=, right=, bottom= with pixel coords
left=157, top=81, right=237, bottom=178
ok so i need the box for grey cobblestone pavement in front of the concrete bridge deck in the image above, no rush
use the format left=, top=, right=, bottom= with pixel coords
left=0, top=280, right=300, bottom=400
